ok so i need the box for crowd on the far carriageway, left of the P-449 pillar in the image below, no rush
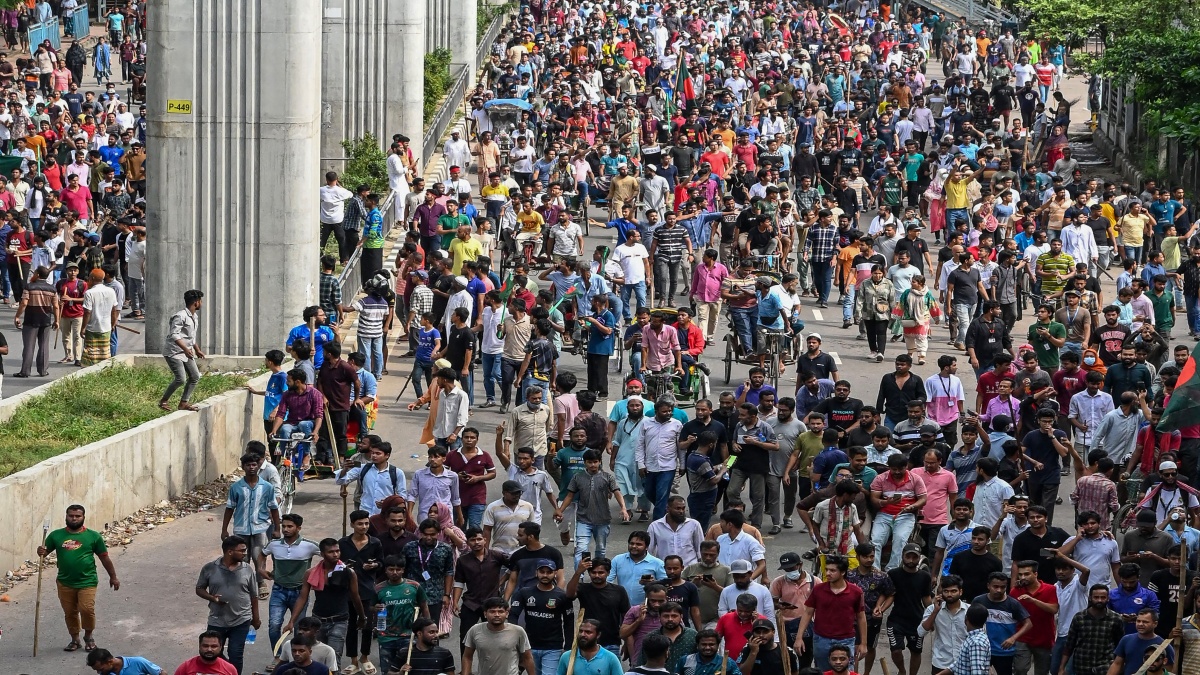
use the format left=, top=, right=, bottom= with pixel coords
left=0, top=0, right=148, bottom=393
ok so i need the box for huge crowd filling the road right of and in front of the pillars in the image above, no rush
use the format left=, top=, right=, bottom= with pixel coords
left=18, top=0, right=1200, bottom=675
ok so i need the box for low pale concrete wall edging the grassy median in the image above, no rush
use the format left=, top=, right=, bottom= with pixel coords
left=0, top=356, right=270, bottom=569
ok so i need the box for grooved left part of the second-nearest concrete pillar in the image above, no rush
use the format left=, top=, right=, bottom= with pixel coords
left=320, top=0, right=386, bottom=172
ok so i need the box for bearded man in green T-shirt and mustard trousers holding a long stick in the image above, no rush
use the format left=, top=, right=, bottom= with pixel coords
left=37, top=504, right=121, bottom=651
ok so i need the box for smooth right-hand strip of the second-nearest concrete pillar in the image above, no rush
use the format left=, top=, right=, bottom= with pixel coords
left=384, top=0, right=427, bottom=162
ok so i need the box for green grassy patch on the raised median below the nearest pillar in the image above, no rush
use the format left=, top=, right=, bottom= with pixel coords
left=0, top=364, right=247, bottom=477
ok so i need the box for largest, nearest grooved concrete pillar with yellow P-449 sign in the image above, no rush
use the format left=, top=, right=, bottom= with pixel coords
left=146, top=0, right=322, bottom=356
